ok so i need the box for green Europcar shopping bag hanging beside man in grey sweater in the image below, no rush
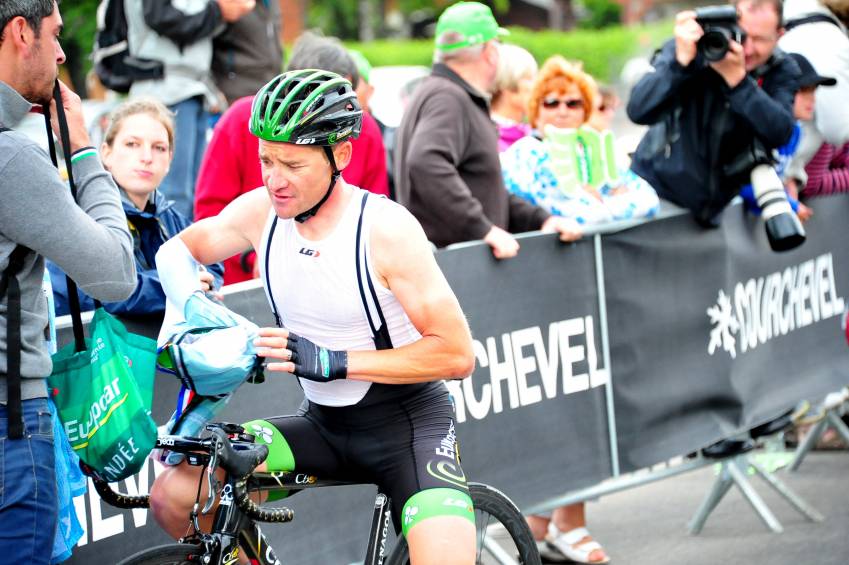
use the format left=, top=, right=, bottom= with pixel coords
left=48, top=308, right=157, bottom=482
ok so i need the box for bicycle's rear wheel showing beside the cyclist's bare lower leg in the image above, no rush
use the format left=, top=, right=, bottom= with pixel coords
left=386, top=483, right=542, bottom=565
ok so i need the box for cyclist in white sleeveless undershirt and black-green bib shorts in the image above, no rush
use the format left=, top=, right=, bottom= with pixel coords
left=151, top=70, right=475, bottom=565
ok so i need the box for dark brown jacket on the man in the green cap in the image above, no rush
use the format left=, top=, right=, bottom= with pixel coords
left=395, top=63, right=549, bottom=247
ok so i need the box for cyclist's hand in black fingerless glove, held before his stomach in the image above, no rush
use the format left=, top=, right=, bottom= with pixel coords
left=254, top=328, right=348, bottom=382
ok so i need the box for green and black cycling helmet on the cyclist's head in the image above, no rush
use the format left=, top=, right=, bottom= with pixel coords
left=250, top=69, right=363, bottom=145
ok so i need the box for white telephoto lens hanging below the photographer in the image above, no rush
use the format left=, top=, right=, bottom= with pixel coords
left=751, top=164, right=805, bottom=251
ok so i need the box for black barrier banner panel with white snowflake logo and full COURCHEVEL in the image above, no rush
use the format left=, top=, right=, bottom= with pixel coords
left=603, top=196, right=849, bottom=472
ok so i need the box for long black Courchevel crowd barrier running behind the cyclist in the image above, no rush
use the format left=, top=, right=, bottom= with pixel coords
left=60, top=196, right=849, bottom=564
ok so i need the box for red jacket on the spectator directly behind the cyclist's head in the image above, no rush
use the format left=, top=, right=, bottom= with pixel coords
left=195, top=96, right=389, bottom=284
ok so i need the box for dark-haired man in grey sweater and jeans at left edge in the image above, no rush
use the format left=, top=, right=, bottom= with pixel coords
left=0, top=0, right=136, bottom=563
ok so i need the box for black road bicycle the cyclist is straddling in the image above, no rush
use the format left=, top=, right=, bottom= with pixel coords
left=94, top=423, right=541, bottom=565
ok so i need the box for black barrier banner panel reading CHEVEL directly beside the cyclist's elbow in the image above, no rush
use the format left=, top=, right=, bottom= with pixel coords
left=437, top=236, right=611, bottom=506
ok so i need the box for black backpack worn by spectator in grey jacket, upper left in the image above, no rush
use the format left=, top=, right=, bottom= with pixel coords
left=91, top=0, right=164, bottom=94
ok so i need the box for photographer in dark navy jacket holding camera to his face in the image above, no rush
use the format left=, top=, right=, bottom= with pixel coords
left=628, top=0, right=799, bottom=226
